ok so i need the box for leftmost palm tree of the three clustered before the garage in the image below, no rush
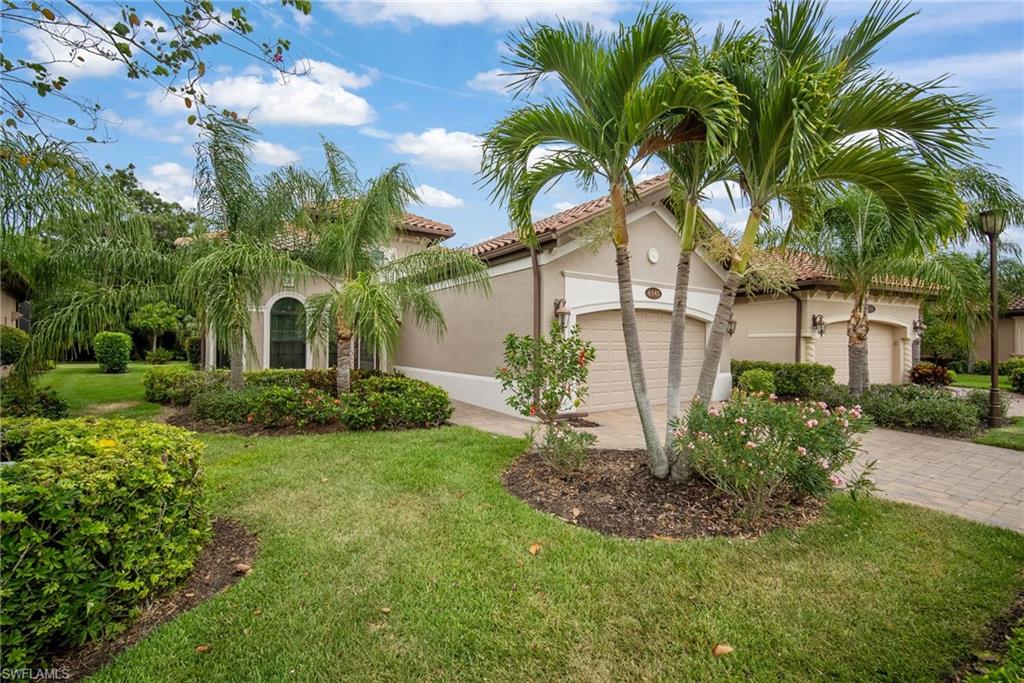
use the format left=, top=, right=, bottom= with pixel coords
left=481, top=5, right=738, bottom=477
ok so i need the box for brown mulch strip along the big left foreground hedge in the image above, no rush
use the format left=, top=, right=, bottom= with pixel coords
left=48, top=519, right=259, bottom=681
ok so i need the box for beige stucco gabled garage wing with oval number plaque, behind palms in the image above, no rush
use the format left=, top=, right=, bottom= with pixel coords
left=394, top=175, right=731, bottom=412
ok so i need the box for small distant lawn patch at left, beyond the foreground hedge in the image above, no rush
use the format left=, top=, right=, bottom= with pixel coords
left=40, top=362, right=180, bottom=418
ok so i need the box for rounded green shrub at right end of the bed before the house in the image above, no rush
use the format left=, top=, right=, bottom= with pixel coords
left=341, top=375, right=453, bottom=430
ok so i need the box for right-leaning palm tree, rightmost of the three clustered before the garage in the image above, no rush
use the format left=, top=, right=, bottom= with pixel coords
left=697, top=0, right=987, bottom=400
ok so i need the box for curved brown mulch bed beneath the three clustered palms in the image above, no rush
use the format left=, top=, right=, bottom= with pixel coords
left=502, top=451, right=823, bottom=540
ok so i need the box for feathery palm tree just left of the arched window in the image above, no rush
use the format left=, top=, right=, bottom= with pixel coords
left=177, top=119, right=311, bottom=389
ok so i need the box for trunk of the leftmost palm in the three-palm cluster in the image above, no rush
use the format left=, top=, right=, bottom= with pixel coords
left=610, top=183, right=669, bottom=479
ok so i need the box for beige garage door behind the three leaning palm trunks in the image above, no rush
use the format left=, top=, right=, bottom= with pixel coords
left=577, top=310, right=705, bottom=411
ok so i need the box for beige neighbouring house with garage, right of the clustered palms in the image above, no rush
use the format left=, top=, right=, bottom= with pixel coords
left=732, top=252, right=925, bottom=384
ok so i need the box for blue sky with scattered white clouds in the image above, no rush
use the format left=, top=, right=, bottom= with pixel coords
left=12, top=0, right=1024, bottom=244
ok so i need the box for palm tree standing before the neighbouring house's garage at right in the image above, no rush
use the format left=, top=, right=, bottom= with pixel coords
left=790, top=187, right=985, bottom=394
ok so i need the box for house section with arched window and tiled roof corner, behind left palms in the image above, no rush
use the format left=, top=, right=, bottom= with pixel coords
left=204, top=213, right=455, bottom=370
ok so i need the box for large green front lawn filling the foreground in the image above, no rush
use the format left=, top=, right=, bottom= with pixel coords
left=36, top=371, right=1024, bottom=681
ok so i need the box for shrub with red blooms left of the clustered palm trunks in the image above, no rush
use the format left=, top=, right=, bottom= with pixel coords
left=497, top=321, right=597, bottom=470
